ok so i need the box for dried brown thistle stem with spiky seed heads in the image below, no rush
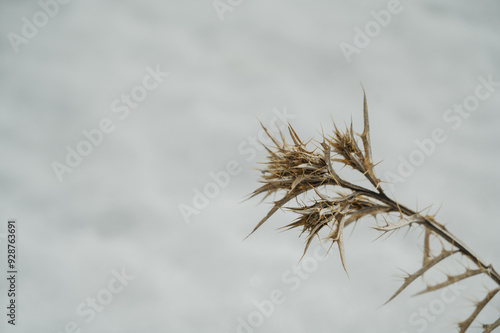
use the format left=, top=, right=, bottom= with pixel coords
left=250, top=90, right=500, bottom=332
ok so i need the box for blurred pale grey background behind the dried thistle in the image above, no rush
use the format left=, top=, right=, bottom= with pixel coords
left=0, top=0, right=500, bottom=333
